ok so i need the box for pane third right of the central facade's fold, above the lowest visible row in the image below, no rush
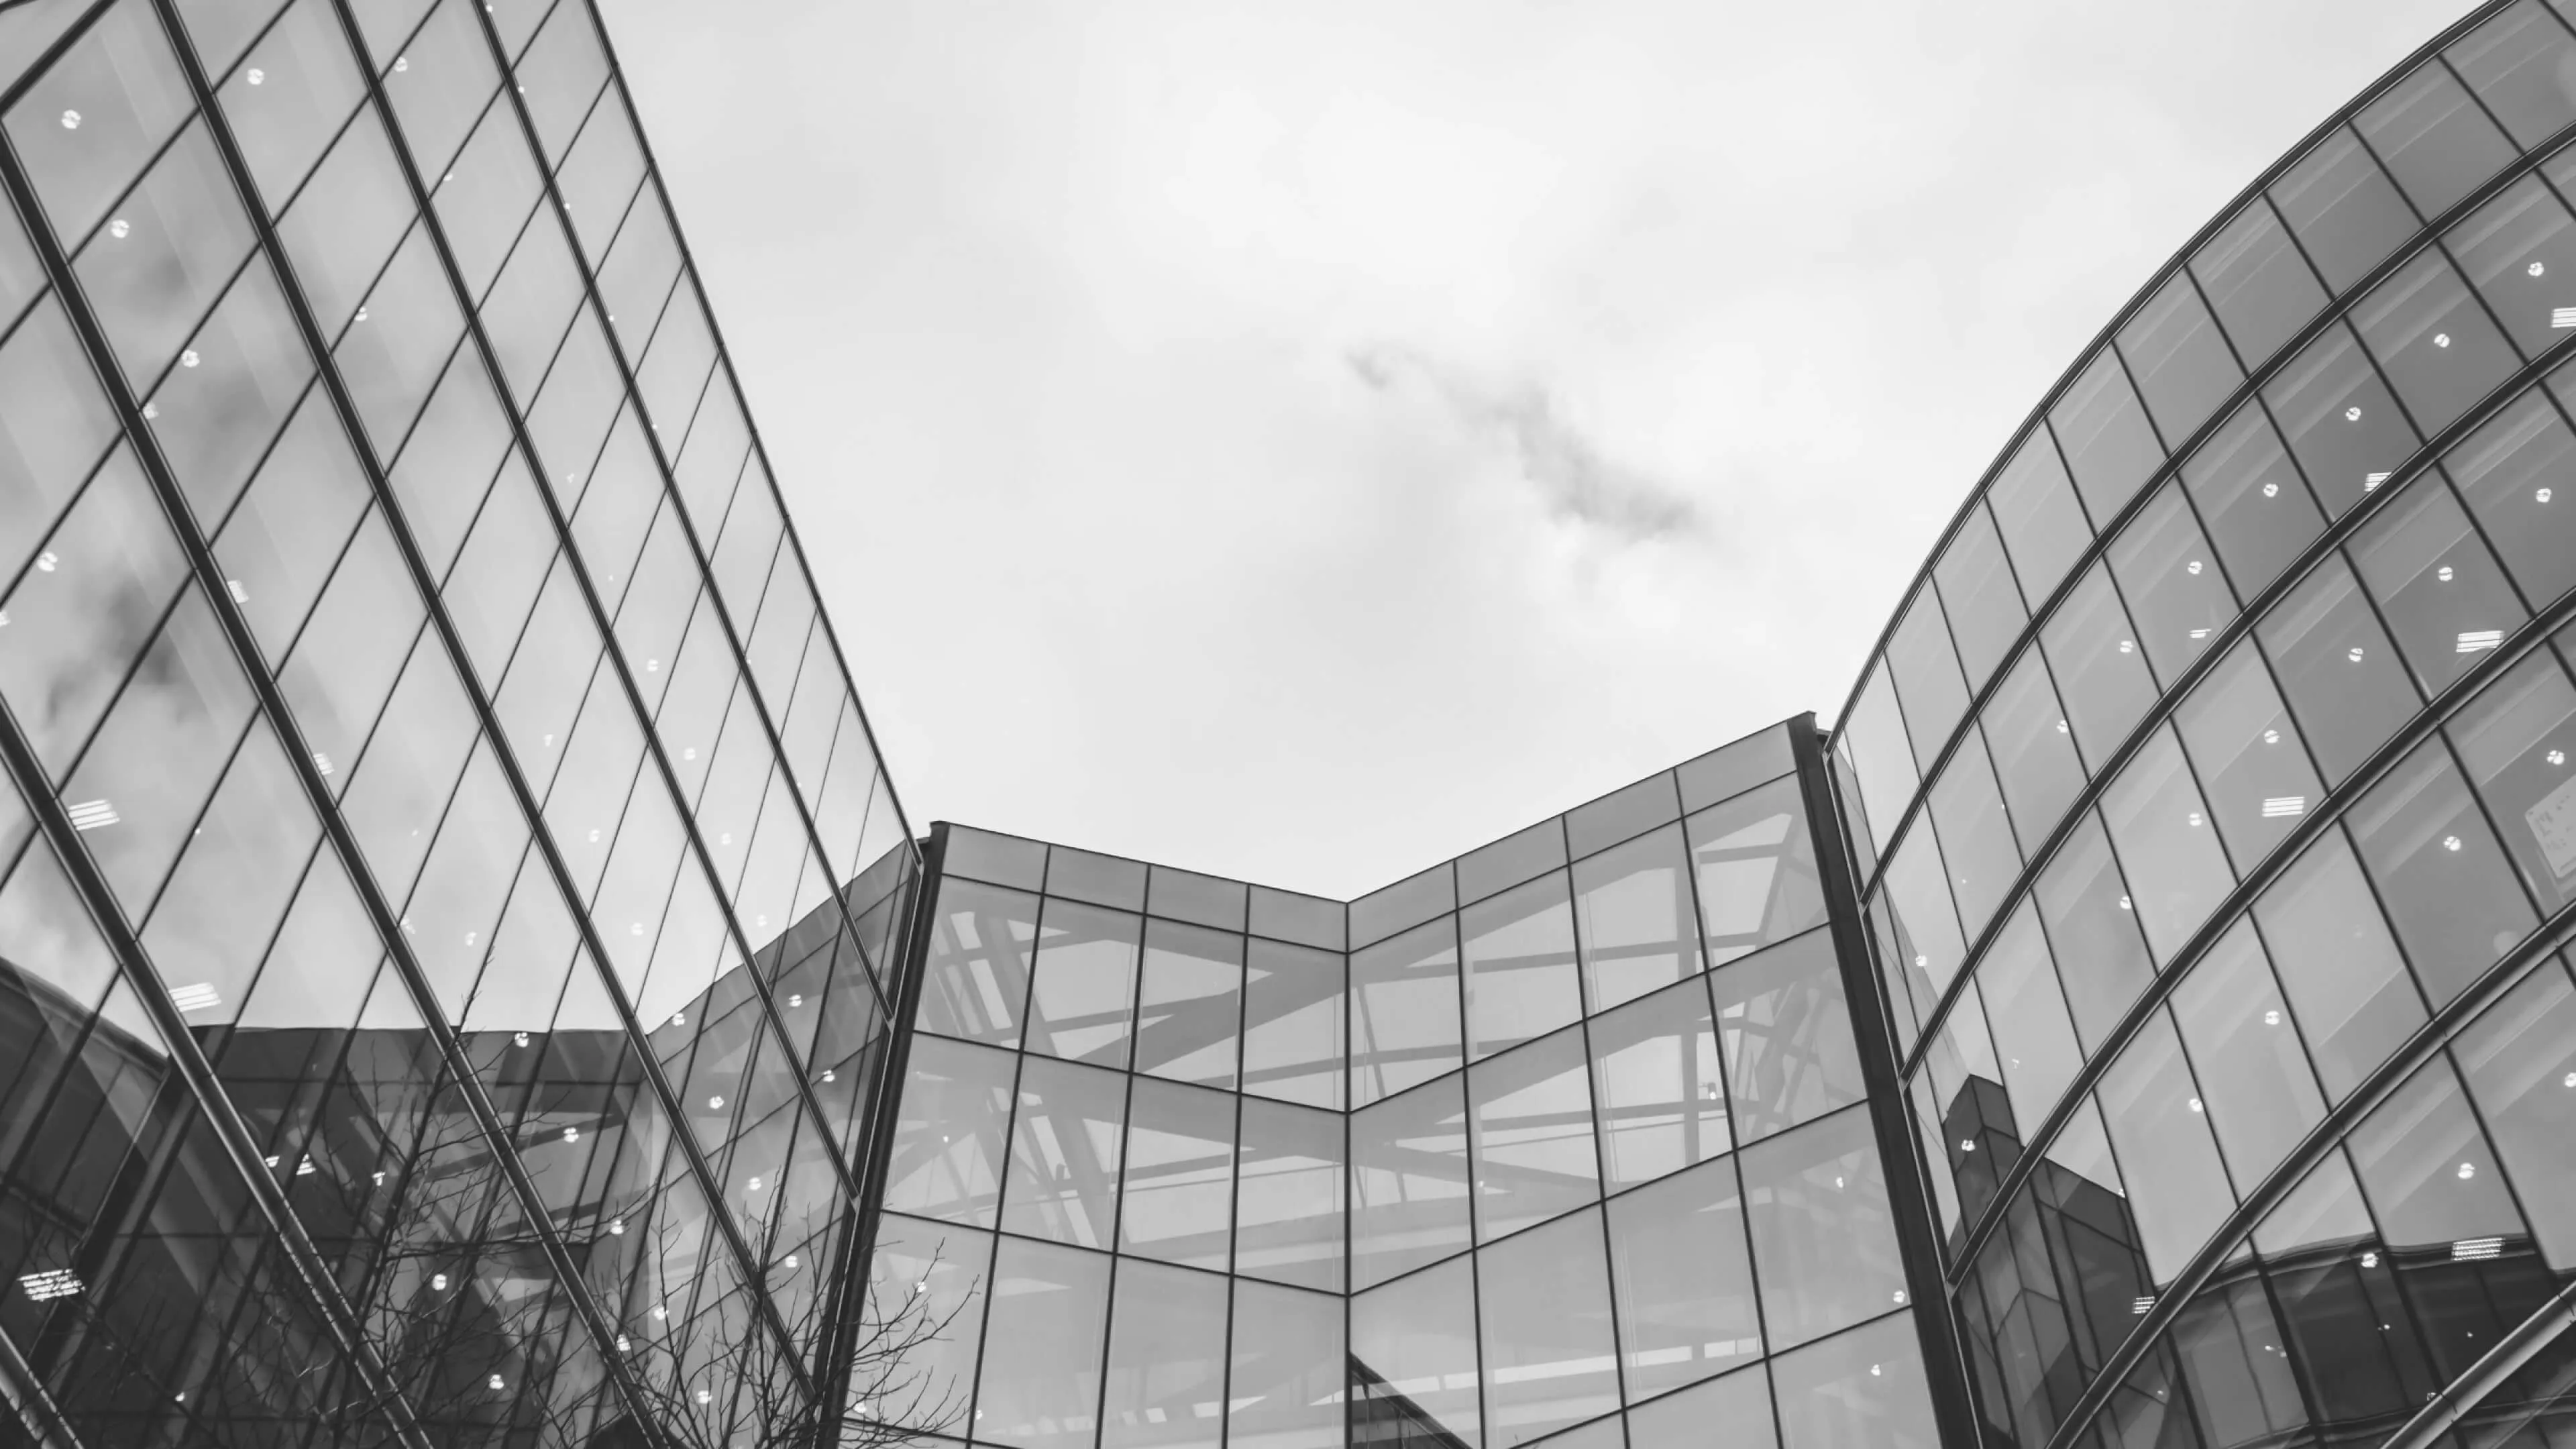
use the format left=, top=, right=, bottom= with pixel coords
left=1610, top=1144, right=1762, bottom=1400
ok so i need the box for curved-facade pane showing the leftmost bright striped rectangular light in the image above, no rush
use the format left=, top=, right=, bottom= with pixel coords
left=2174, top=642, right=2326, bottom=869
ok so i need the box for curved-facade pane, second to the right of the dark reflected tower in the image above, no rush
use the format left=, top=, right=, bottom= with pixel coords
left=2174, top=920, right=2326, bottom=1183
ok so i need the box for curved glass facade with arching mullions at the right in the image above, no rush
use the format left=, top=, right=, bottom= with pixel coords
left=1831, top=0, right=2576, bottom=1449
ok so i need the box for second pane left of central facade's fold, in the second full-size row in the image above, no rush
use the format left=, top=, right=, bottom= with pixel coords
left=1118, top=1073, right=1234, bottom=1271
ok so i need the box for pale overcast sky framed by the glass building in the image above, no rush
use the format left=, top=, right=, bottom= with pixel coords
left=605, top=0, right=2460, bottom=898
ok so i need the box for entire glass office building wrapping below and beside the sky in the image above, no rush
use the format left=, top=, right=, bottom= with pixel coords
left=0, top=0, right=2576, bottom=1449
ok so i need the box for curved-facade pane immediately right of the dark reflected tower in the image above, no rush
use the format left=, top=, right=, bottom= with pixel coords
left=2100, top=1011, right=2236, bottom=1284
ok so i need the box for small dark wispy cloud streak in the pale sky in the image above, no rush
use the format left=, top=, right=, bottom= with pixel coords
left=1342, top=343, right=1703, bottom=541
